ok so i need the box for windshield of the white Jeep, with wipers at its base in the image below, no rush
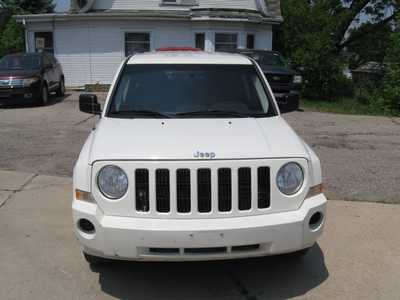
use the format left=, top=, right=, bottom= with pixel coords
left=108, top=64, right=275, bottom=118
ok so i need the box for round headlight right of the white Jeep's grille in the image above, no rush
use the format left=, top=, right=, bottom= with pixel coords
left=276, top=162, right=304, bottom=196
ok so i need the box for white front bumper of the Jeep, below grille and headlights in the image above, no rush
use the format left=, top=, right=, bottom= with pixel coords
left=72, top=194, right=327, bottom=261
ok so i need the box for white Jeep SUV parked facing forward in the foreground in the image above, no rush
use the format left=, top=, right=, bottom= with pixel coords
left=72, top=51, right=327, bottom=263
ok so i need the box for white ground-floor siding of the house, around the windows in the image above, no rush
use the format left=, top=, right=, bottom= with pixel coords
left=27, top=21, right=272, bottom=87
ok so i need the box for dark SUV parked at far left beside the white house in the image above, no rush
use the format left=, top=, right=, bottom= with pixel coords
left=0, top=53, right=65, bottom=105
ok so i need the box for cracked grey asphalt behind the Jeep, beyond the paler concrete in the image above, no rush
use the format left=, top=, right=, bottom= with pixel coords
left=0, top=92, right=400, bottom=203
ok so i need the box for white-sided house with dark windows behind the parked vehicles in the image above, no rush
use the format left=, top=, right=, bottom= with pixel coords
left=17, top=0, right=282, bottom=87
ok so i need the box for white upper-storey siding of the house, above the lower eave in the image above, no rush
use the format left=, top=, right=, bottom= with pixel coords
left=93, top=0, right=258, bottom=10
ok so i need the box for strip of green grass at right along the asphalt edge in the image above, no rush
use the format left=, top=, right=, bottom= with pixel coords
left=300, top=98, right=385, bottom=116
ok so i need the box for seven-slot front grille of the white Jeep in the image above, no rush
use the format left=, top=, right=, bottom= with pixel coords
left=135, top=167, right=271, bottom=214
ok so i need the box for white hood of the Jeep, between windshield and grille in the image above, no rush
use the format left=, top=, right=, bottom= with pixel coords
left=89, top=117, right=308, bottom=164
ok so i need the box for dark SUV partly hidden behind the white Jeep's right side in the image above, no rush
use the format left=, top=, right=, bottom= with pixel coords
left=238, top=49, right=302, bottom=112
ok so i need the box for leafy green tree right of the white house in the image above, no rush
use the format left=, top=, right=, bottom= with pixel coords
left=276, top=0, right=398, bottom=98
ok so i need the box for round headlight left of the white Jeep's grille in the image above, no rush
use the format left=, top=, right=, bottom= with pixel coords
left=97, top=165, right=128, bottom=200
